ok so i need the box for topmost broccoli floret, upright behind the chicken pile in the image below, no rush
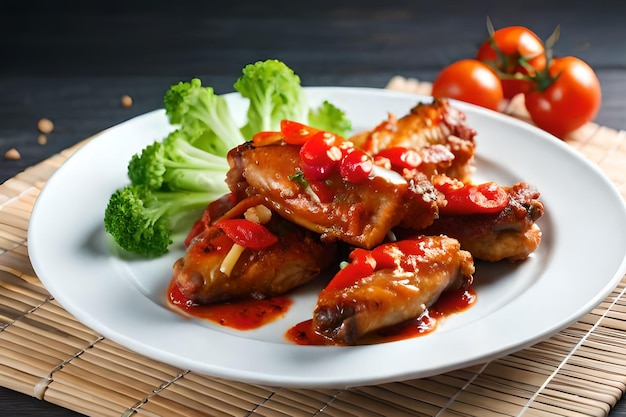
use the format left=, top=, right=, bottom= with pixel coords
left=234, top=59, right=308, bottom=139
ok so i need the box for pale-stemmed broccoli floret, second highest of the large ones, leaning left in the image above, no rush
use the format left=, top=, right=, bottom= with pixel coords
left=163, top=78, right=245, bottom=156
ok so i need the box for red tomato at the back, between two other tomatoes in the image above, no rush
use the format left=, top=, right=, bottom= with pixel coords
left=476, top=26, right=546, bottom=99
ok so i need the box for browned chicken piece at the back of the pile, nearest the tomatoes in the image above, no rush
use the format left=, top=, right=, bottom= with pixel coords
left=350, top=98, right=476, bottom=181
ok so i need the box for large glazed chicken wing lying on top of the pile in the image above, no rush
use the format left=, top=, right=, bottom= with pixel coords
left=226, top=142, right=438, bottom=248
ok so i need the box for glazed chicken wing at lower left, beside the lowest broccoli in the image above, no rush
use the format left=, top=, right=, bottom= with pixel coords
left=173, top=204, right=337, bottom=304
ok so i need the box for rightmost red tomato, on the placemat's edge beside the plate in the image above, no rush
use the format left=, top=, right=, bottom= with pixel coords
left=524, top=56, right=602, bottom=138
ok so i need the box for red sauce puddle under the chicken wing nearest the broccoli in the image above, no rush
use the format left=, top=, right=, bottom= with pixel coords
left=167, top=280, right=293, bottom=330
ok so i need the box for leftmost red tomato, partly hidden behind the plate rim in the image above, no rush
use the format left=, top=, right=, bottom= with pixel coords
left=432, top=59, right=504, bottom=110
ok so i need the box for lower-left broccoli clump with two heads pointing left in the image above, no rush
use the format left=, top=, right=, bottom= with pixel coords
left=112, top=129, right=229, bottom=257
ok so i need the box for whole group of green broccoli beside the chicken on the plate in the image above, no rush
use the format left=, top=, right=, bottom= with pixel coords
left=104, top=60, right=351, bottom=257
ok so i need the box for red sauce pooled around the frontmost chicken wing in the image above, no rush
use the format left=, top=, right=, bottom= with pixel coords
left=285, top=286, right=476, bottom=346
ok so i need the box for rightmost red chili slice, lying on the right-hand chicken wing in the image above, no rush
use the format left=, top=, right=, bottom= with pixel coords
left=435, top=182, right=509, bottom=216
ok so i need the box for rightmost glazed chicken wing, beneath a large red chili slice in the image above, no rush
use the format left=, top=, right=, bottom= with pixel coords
left=410, top=182, right=544, bottom=262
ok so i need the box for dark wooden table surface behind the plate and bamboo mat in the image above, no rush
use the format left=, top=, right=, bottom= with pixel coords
left=0, top=0, right=626, bottom=417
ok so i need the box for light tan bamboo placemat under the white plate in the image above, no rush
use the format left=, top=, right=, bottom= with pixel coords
left=0, top=77, right=626, bottom=417
